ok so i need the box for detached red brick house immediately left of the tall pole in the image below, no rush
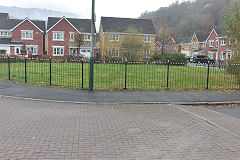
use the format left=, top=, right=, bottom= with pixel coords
left=46, top=17, right=96, bottom=58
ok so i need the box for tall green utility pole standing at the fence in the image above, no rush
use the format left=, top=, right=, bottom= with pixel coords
left=89, top=0, right=96, bottom=91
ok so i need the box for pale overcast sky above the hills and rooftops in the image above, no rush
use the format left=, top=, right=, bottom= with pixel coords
left=0, top=0, right=187, bottom=18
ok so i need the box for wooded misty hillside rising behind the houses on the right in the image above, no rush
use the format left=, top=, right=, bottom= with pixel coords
left=140, top=0, right=232, bottom=37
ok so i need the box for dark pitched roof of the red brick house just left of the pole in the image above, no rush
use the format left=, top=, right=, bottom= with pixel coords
left=47, top=17, right=93, bottom=33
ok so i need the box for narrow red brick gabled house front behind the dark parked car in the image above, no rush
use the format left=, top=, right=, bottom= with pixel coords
left=206, top=29, right=219, bottom=59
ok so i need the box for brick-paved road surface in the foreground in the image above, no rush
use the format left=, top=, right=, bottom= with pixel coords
left=0, top=97, right=240, bottom=160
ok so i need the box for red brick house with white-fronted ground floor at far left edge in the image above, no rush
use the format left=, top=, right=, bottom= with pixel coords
left=0, top=14, right=45, bottom=55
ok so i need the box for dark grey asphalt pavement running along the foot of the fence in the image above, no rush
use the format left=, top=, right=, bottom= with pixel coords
left=0, top=82, right=240, bottom=104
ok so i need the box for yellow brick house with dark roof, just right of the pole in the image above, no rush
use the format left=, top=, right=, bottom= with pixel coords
left=99, top=17, right=156, bottom=59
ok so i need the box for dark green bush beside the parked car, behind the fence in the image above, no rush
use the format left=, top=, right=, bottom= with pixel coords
left=152, top=53, right=187, bottom=64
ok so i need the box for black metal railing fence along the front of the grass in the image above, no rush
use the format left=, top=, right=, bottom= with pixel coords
left=0, top=57, right=240, bottom=91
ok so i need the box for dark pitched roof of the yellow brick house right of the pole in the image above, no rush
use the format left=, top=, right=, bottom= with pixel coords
left=101, top=17, right=156, bottom=34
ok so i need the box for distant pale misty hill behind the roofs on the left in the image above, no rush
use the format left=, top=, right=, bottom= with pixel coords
left=0, top=6, right=81, bottom=20
